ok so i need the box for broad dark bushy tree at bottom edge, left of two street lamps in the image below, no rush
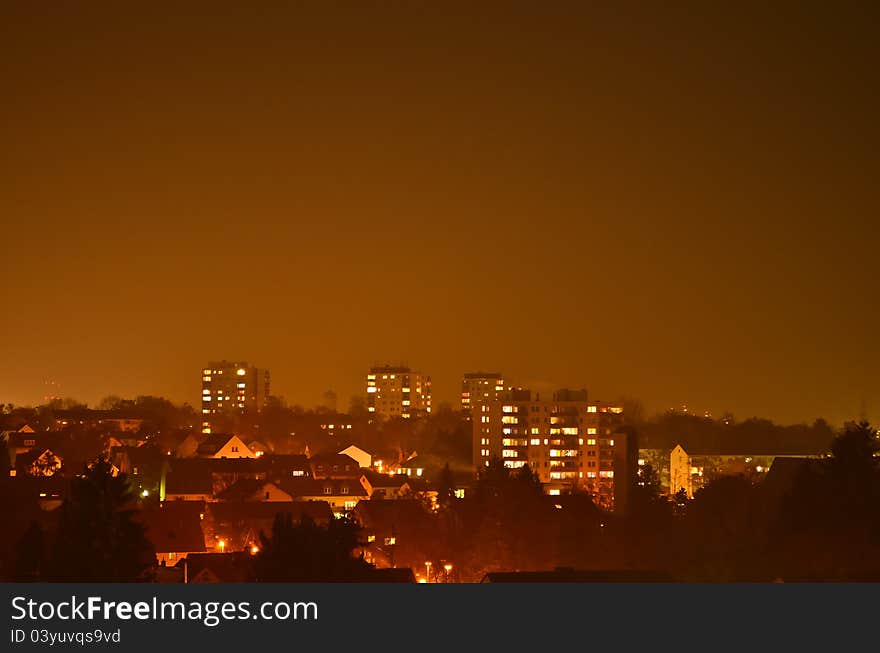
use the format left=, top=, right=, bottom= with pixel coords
left=254, top=513, right=373, bottom=583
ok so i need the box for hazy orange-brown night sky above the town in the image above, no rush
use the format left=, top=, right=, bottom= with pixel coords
left=0, top=3, right=880, bottom=423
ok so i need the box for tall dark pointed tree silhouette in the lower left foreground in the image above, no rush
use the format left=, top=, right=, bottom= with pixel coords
left=50, top=458, right=155, bottom=582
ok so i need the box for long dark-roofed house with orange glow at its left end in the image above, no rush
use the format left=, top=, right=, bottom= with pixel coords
left=204, top=501, right=333, bottom=551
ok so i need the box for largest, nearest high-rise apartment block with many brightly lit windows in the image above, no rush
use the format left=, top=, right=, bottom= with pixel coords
left=471, top=390, right=638, bottom=511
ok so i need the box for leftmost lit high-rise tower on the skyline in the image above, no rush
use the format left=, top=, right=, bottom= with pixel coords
left=202, top=360, right=269, bottom=433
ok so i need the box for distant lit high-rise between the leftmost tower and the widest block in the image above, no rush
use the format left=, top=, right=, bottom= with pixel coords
left=367, top=365, right=431, bottom=419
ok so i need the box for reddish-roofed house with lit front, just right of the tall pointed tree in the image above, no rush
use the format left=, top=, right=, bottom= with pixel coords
left=137, top=501, right=206, bottom=567
